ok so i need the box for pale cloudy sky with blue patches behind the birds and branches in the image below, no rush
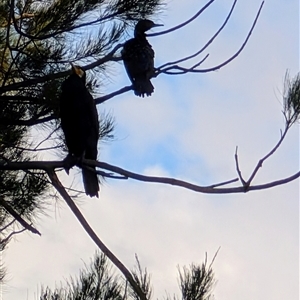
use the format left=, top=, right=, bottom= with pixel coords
left=3, top=0, right=299, bottom=300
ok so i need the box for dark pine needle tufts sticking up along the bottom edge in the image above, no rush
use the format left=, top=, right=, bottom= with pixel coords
left=40, top=252, right=215, bottom=300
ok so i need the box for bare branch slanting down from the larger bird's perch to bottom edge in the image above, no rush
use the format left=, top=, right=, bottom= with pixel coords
left=47, top=168, right=147, bottom=300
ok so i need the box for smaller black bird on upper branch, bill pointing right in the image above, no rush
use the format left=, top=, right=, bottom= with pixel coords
left=121, top=20, right=163, bottom=97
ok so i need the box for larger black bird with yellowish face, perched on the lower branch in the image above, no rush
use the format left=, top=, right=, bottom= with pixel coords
left=60, top=65, right=99, bottom=198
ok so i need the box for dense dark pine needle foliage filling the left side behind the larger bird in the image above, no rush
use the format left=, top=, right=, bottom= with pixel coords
left=0, top=0, right=161, bottom=274
